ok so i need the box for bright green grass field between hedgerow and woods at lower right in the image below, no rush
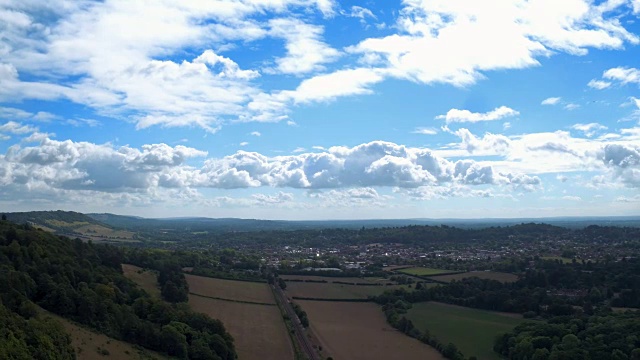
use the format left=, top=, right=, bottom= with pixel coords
left=407, top=302, right=524, bottom=360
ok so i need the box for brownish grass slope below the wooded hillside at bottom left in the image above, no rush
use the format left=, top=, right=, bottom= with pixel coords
left=40, top=310, right=167, bottom=360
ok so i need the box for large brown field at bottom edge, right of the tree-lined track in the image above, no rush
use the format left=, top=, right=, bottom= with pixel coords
left=296, top=300, right=444, bottom=360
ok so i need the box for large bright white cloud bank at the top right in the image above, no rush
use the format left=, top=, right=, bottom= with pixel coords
left=349, top=0, right=639, bottom=86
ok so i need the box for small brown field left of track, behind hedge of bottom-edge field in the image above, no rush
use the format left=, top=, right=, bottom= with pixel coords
left=184, top=274, right=276, bottom=304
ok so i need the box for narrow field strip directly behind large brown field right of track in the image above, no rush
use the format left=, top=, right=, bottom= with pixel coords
left=285, top=282, right=404, bottom=299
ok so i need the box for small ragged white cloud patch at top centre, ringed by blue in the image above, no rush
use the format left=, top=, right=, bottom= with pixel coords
left=269, top=18, right=340, bottom=75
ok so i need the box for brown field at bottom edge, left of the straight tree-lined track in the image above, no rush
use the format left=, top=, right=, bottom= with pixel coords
left=189, top=294, right=294, bottom=360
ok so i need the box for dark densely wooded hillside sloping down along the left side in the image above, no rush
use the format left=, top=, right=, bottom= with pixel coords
left=0, top=221, right=236, bottom=360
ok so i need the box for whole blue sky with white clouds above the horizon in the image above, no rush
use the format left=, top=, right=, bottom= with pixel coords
left=0, top=0, right=640, bottom=220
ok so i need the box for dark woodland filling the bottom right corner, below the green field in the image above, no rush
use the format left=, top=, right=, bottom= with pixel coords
left=494, top=312, right=640, bottom=360
